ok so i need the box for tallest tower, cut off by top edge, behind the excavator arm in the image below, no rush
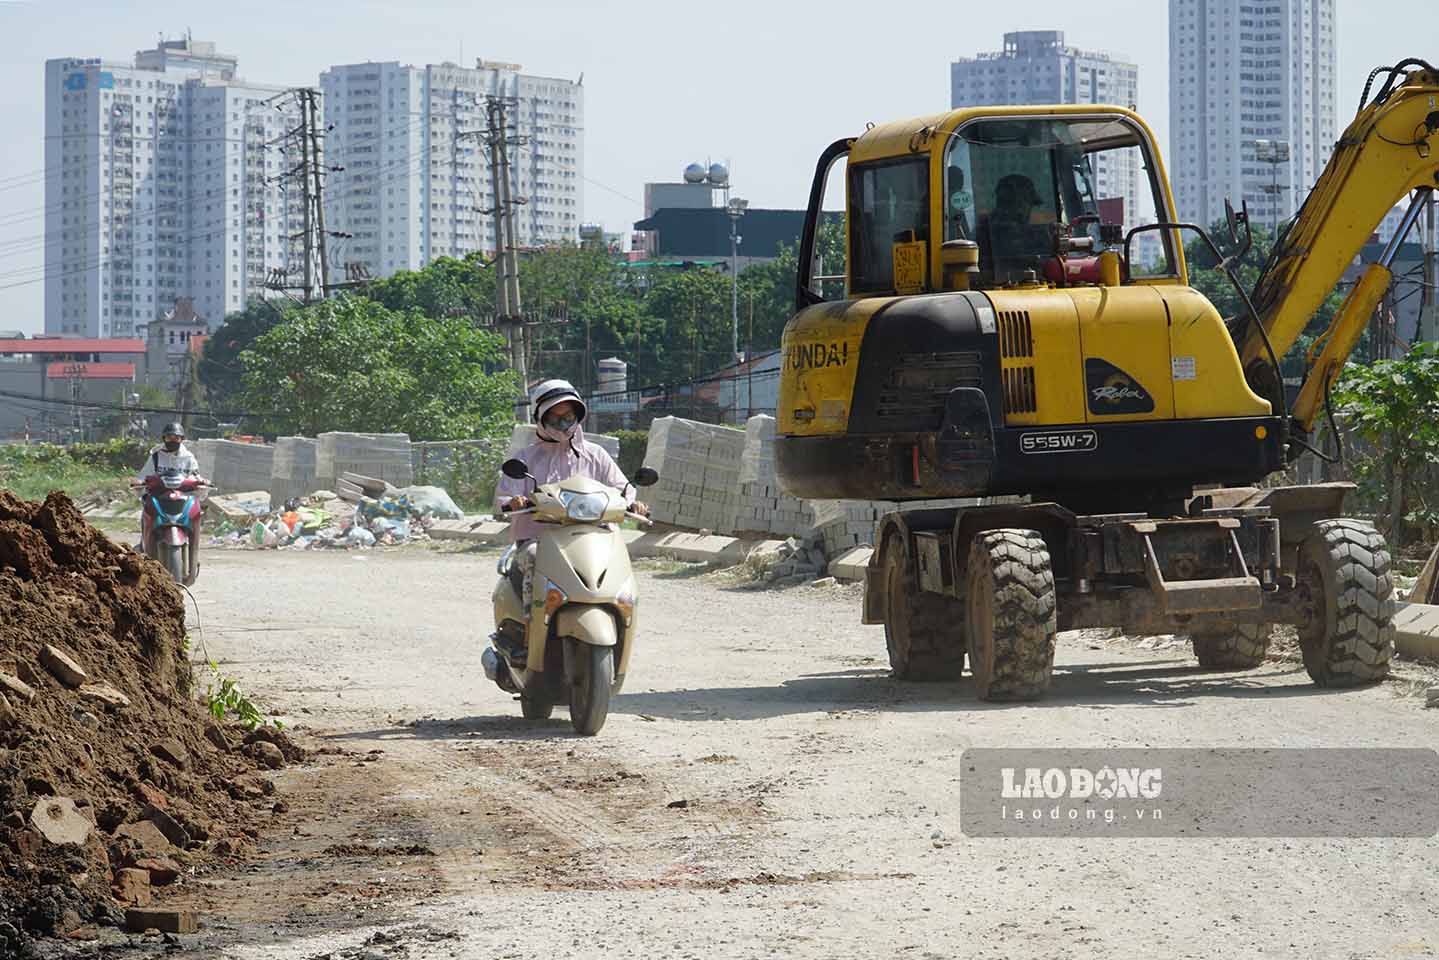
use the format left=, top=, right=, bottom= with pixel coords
left=1168, top=0, right=1335, bottom=226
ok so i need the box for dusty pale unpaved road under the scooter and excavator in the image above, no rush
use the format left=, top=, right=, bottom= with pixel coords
left=146, top=548, right=1439, bottom=960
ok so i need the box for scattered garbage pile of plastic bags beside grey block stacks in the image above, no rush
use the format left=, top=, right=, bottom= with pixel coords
left=206, top=474, right=465, bottom=550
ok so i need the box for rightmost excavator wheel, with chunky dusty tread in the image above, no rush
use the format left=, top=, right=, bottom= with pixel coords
left=1299, top=518, right=1396, bottom=687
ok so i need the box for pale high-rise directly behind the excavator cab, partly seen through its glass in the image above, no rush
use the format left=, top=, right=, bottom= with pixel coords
left=950, top=30, right=1153, bottom=226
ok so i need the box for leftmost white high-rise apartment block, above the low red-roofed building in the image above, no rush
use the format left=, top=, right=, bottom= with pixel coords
left=45, top=37, right=304, bottom=337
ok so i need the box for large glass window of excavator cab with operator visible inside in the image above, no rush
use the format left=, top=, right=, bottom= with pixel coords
left=943, top=117, right=1173, bottom=286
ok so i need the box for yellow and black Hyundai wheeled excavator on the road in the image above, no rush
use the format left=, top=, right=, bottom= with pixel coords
left=776, top=59, right=1439, bottom=699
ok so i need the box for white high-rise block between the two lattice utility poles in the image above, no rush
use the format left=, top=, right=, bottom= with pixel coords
left=319, top=60, right=584, bottom=276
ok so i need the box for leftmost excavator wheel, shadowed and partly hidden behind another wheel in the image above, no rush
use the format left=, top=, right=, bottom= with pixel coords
left=884, top=537, right=964, bottom=681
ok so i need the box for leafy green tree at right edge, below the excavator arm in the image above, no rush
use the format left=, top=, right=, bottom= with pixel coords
left=1334, top=343, right=1439, bottom=547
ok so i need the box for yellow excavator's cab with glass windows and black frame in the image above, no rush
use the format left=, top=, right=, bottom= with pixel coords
left=799, top=108, right=1184, bottom=308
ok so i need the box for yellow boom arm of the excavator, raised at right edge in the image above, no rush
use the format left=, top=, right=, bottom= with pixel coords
left=1240, top=60, right=1439, bottom=391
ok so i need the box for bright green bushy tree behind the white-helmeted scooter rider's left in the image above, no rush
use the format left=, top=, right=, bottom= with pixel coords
left=240, top=295, right=518, bottom=440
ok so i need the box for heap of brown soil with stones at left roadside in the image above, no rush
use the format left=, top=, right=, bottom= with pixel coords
left=0, top=491, right=301, bottom=956
